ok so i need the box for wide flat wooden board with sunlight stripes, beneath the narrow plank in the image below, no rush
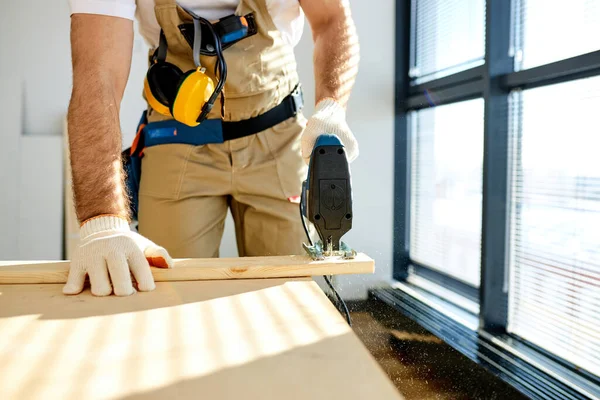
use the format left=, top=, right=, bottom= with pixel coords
left=0, top=279, right=402, bottom=400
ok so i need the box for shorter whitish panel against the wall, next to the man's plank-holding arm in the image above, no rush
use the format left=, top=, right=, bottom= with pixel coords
left=18, top=136, right=63, bottom=260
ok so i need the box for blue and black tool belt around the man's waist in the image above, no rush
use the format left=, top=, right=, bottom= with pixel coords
left=122, top=84, right=304, bottom=218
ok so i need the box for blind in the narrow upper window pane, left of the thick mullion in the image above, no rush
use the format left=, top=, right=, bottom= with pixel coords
left=409, top=0, right=485, bottom=83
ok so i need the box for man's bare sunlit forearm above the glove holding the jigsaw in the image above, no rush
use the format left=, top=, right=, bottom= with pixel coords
left=313, top=8, right=360, bottom=107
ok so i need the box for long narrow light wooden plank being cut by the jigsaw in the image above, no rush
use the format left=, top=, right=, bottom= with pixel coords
left=0, top=253, right=375, bottom=284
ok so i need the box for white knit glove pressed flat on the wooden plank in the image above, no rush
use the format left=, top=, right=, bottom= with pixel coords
left=63, top=216, right=173, bottom=296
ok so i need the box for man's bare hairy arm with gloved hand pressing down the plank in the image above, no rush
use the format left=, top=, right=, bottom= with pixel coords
left=63, top=14, right=158, bottom=296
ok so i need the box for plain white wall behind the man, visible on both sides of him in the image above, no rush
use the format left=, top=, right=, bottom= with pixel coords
left=0, top=0, right=395, bottom=298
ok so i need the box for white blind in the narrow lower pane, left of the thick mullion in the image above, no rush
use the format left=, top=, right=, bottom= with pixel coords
left=409, top=99, right=483, bottom=287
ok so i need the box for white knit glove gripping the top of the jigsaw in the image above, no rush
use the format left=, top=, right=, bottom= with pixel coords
left=301, top=98, right=358, bottom=164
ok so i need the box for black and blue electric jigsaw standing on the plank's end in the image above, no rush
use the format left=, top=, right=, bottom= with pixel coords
left=300, top=135, right=356, bottom=260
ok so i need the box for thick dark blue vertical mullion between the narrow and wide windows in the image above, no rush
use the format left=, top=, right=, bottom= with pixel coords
left=479, top=0, right=514, bottom=332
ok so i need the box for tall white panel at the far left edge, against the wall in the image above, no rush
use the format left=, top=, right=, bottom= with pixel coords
left=0, top=76, right=23, bottom=260
